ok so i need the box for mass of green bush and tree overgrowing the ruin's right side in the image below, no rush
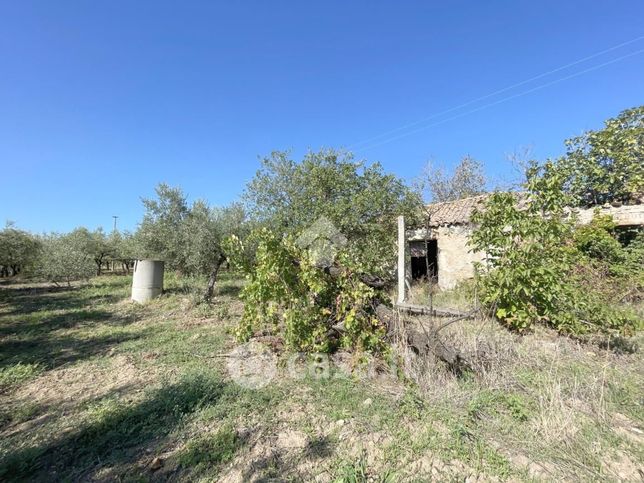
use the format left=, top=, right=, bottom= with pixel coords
left=471, top=109, right=644, bottom=334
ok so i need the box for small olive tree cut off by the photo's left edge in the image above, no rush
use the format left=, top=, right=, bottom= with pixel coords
left=0, top=223, right=40, bottom=276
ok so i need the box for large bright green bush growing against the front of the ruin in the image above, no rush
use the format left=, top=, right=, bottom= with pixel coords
left=471, top=162, right=641, bottom=334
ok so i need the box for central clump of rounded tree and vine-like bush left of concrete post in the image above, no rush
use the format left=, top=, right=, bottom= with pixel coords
left=228, top=150, right=420, bottom=352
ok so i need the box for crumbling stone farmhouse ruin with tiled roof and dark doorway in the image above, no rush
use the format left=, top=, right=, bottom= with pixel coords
left=405, top=195, right=644, bottom=289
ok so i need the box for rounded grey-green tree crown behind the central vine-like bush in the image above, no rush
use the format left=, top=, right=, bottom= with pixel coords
left=244, top=149, right=422, bottom=275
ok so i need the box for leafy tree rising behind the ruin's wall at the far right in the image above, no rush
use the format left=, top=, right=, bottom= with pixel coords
left=557, top=106, right=644, bottom=206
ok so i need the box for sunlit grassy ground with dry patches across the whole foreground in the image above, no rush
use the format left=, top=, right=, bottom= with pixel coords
left=0, top=274, right=644, bottom=482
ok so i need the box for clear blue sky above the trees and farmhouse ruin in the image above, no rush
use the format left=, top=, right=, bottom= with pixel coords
left=0, top=0, right=644, bottom=231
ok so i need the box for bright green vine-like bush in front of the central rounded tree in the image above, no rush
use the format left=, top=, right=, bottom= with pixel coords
left=227, top=228, right=385, bottom=352
